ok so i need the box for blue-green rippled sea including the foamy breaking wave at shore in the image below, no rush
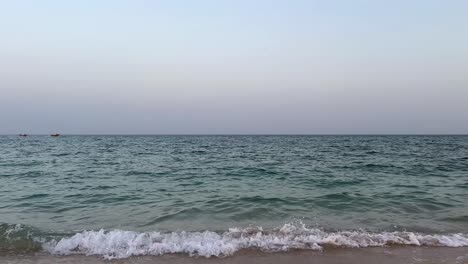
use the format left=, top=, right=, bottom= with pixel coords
left=0, top=135, right=468, bottom=258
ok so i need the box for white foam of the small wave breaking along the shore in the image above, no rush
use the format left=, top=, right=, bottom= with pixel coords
left=43, top=224, right=468, bottom=259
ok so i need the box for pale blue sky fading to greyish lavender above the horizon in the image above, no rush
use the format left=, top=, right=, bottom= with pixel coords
left=0, top=0, right=468, bottom=134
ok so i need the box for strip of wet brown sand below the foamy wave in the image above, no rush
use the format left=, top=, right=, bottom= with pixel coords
left=0, top=247, right=468, bottom=264
